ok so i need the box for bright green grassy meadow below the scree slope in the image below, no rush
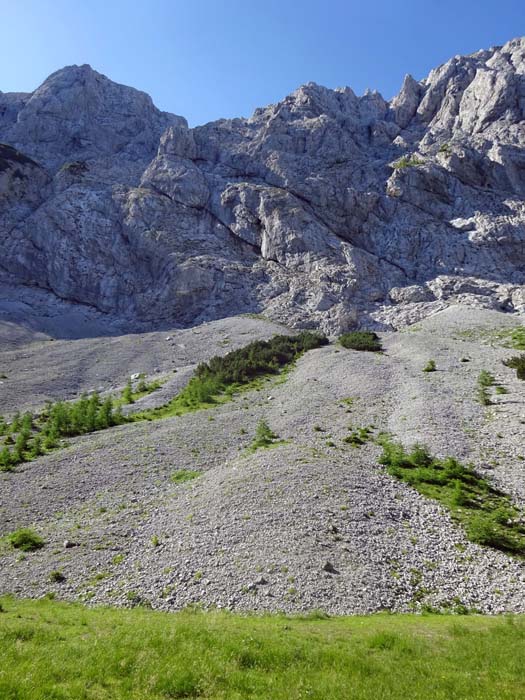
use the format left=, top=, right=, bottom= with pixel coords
left=0, top=598, right=525, bottom=700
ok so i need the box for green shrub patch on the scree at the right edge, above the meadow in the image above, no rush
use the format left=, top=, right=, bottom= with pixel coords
left=379, top=436, right=525, bottom=557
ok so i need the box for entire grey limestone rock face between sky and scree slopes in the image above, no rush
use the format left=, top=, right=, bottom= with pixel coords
left=0, top=39, right=525, bottom=332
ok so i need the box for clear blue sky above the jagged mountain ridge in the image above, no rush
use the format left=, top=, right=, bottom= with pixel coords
left=0, top=0, right=525, bottom=125
